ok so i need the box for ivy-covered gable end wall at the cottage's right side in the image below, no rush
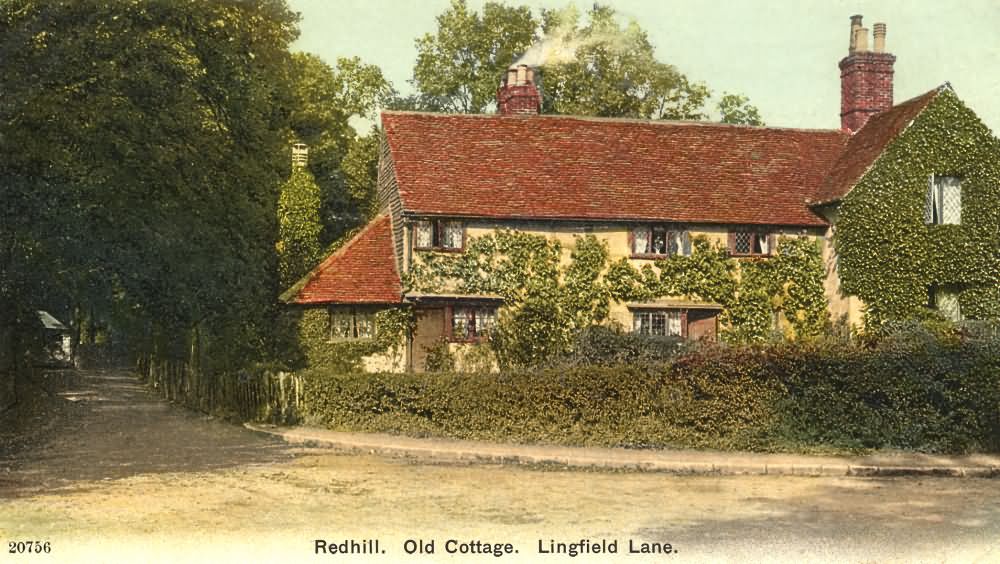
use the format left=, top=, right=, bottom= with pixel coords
left=834, top=88, right=1000, bottom=326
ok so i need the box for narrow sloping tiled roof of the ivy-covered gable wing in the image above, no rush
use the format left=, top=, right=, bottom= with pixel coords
left=816, top=86, right=944, bottom=203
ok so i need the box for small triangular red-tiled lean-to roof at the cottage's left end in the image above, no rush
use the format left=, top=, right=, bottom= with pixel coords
left=281, top=215, right=403, bottom=304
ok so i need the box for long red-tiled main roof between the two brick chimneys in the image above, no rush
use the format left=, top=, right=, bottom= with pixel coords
left=382, top=112, right=848, bottom=226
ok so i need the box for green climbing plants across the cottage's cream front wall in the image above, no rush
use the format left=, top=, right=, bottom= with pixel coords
left=404, top=229, right=827, bottom=366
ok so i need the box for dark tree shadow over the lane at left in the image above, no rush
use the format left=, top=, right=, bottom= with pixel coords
left=0, top=370, right=293, bottom=497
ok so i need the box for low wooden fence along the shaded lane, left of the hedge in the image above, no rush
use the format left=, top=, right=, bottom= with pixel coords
left=138, top=358, right=302, bottom=424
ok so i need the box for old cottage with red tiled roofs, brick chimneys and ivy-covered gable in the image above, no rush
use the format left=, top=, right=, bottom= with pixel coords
left=283, top=16, right=1000, bottom=370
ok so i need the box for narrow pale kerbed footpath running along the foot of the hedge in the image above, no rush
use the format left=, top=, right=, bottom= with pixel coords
left=245, top=423, right=1000, bottom=478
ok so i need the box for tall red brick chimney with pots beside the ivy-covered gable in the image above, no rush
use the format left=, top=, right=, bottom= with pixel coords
left=840, top=16, right=896, bottom=133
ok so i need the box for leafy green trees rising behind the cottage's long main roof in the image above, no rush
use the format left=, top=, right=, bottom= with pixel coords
left=406, top=0, right=753, bottom=119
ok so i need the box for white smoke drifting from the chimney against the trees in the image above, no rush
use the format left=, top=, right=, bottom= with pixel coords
left=514, top=5, right=642, bottom=67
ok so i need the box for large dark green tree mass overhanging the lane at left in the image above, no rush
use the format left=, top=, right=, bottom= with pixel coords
left=0, top=0, right=297, bottom=366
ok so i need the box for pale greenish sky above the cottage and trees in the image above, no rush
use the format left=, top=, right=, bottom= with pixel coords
left=289, top=0, right=1000, bottom=133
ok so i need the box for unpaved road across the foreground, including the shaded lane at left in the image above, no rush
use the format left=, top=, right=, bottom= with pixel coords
left=0, top=372, right=1000, bottom=563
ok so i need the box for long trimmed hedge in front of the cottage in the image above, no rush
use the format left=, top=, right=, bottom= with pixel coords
left=303, top=329, right=1000, bottom=452
